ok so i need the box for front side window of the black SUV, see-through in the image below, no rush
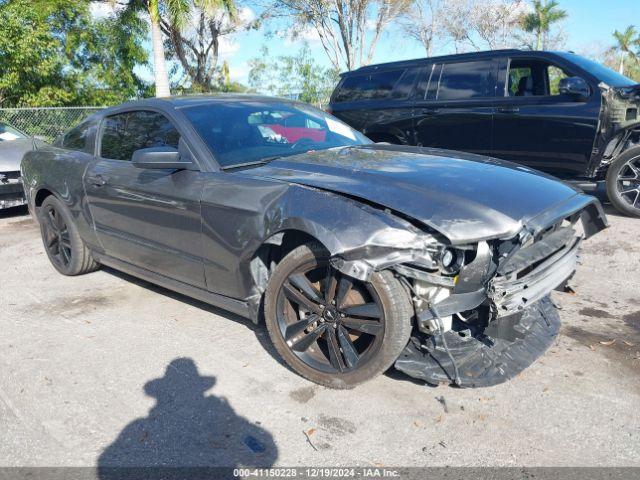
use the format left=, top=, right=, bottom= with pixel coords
left=506, top=59, right=571, bottom=97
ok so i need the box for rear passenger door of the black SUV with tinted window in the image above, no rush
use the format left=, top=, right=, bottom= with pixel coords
left=413, top=59, right=496, bottom=154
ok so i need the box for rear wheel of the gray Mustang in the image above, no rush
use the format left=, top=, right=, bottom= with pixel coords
left=38, top=195, right=99, bottom=276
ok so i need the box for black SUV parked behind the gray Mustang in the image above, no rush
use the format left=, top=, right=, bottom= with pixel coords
left=329, top=50, right=640, bottom=216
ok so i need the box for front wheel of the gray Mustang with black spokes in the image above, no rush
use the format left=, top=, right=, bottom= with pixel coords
left=264, top=243, right=413, bottom=389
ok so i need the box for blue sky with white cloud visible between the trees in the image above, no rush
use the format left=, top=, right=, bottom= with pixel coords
left=90, top=0, right=640, bottom=84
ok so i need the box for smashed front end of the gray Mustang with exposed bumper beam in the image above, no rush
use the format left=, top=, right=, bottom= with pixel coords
left=332, top=195, right=607, bottom=387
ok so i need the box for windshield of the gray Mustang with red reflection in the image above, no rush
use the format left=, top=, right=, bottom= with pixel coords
left=183, top=100, right=371, bottom=167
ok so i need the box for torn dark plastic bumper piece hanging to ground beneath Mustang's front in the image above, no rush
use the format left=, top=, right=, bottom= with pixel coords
left=395, top=296, right=560, bottom=388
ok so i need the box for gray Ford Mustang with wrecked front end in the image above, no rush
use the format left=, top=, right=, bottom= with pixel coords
left=22, top=96, right=607, bottom=388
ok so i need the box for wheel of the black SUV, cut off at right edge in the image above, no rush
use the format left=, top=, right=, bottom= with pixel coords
left=606, top=147, right=640, bottom=217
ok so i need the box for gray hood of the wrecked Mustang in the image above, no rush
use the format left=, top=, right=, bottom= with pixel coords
left=244, top=145, right=592, bottom=244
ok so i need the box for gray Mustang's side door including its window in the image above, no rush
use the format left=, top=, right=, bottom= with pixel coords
left=85, top=110, right=205, bottom=287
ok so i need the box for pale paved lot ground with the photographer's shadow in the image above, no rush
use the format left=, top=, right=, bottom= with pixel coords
left=0, top=204, right=640, bottom=466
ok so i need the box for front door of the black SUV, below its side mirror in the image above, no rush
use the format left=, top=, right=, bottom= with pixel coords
left=492, top=57, right=600, bottom=178
